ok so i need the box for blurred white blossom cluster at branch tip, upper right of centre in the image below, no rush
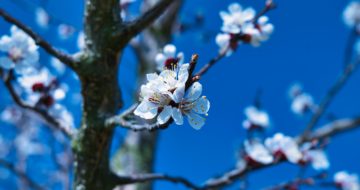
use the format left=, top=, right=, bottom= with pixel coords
left=216, top=3, right=274, bottom=55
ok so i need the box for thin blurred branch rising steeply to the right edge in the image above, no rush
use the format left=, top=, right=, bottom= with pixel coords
left=302, top=57, right=360, bottom=138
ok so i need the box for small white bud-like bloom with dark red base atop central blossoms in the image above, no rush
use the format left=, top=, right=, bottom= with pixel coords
left=155, top=44, right=184, bottom=71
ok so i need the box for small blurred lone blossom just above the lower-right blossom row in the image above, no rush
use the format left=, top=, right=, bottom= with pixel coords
left=243, top=106, right=270, bottom=129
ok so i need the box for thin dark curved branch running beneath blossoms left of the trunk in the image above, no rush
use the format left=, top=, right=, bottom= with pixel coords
left=4, top=71, right=74, bottom=137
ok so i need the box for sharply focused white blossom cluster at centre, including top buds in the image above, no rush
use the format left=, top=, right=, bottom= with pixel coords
left=134, top=45, right=210, bottom=129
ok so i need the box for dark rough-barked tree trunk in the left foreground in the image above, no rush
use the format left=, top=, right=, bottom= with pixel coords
left=73, top=0, right=122, bottom=190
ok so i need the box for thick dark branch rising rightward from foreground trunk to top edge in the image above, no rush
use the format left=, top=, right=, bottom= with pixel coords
left=116, top=0, right=175, bottom=47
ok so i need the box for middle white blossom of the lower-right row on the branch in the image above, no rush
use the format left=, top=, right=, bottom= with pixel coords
left=265, top=133, right=302, bottom=164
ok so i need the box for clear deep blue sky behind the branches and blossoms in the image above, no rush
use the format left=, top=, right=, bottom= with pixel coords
left=0, top=0, right=360, bottom=189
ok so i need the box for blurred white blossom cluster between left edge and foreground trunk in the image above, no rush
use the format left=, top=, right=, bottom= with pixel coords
left=0, top=26, right=73, bottom=127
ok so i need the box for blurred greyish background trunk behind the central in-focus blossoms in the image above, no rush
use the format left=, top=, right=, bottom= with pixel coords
left=112, top=0, right=182, bottom=190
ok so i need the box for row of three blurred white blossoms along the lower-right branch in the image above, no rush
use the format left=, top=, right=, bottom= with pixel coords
left=243, top=133, right=330, bottom=170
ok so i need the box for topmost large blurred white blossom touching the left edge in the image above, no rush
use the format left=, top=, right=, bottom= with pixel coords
left=0, top=26, right=39, bottom=74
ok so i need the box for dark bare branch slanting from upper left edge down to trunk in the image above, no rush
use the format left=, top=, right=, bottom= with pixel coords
left=0, top=9, right=76, bottom=69
